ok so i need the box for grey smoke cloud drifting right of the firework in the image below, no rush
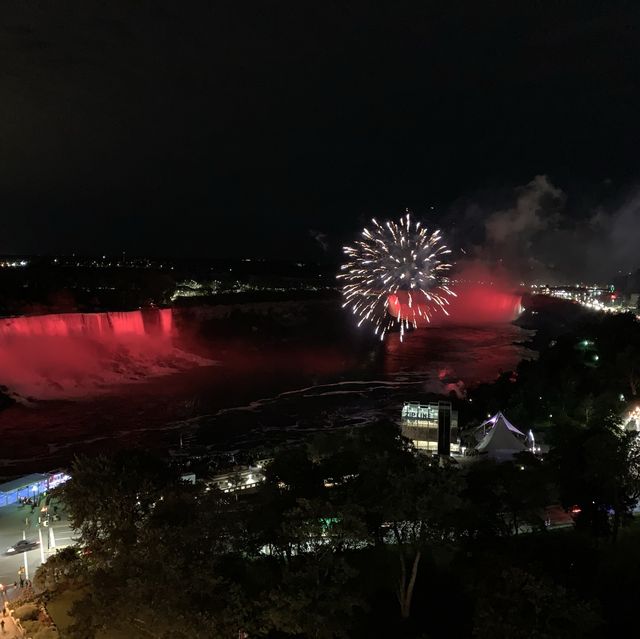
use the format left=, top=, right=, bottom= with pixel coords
left=451, top=175, right=640, bottom=283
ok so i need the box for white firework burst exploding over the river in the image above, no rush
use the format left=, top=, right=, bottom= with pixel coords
left=338, top=213, right=455, bottom=340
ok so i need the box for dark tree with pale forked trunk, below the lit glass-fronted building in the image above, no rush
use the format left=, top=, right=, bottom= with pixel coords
left=260, top=422, right=460, bottom=618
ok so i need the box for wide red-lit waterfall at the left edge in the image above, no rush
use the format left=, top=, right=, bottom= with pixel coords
left=0, top=309, right=184, bottom=398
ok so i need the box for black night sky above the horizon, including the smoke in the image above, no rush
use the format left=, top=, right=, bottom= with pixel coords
left=0, top=0, right=640, bottom=277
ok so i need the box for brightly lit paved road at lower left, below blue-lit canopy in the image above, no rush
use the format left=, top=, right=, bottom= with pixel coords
left=0, top=504, right=73, bottom=598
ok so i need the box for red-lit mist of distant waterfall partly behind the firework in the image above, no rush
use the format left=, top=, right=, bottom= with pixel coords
left=388, top=283, right=521, bottom=327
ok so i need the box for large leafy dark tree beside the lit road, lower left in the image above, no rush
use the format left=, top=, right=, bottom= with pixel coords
left=63, top=452, right=258, bottom=639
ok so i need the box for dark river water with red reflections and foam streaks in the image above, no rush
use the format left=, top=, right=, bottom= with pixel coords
left=0, top=324, right=531, bottom=476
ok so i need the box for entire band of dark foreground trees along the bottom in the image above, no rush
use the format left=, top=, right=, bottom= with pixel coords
left=37, top=422, right=640, bottom=638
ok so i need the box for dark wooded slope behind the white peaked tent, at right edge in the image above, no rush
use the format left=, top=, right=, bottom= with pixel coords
left=466, top=313, right=640, bottom=430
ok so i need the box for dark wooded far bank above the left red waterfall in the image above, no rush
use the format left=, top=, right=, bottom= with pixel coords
left=0, top=256, right=337, bottom=316
